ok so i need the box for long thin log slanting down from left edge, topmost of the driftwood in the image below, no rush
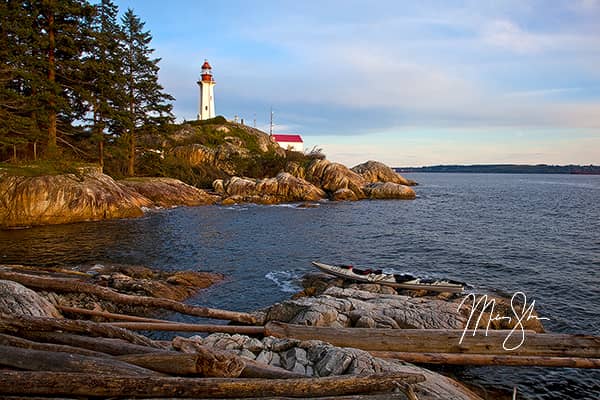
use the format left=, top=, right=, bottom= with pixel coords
left=0, top=270, right=256, bottom=324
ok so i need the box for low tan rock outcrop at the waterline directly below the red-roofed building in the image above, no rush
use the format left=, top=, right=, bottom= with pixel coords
left=213, top=172, right=326, bottom=204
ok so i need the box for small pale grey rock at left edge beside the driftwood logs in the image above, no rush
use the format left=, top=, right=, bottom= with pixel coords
left=0, top=280, right=62, bottom=318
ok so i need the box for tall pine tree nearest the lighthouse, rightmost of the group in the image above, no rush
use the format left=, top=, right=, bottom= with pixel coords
left=122, top=9, right=174, bottom=176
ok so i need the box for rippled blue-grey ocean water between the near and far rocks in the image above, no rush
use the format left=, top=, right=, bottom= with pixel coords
left=0, top=173, right=600, bottom=399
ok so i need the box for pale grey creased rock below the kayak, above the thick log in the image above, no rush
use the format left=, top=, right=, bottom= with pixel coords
left=263, top=286, right=466, bottom=329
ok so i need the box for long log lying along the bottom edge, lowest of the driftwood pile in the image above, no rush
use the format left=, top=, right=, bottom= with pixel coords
left=0, top=371, right=425, bottom=398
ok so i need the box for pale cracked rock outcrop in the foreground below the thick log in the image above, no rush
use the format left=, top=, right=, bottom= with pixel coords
left=190, top=333, right=481, bottom=400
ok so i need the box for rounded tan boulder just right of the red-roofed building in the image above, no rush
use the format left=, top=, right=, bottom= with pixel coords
left=305, top=160, right=367, bottom=199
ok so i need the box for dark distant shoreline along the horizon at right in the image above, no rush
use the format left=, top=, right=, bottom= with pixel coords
left=394, top=164, right=600, bottom=175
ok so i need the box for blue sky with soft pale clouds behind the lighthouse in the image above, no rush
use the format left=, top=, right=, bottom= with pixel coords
left=115, top=0, right=600, bottom=167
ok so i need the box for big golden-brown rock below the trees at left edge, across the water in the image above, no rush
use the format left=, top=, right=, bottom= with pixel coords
left=0, top=168, right=152, bottom=228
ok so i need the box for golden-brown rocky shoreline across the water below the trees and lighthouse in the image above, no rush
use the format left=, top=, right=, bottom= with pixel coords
left=0, top=160, right=416, bottom=228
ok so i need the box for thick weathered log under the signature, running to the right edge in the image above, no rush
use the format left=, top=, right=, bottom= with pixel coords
left=265, top=322, right=600, bottom=358
